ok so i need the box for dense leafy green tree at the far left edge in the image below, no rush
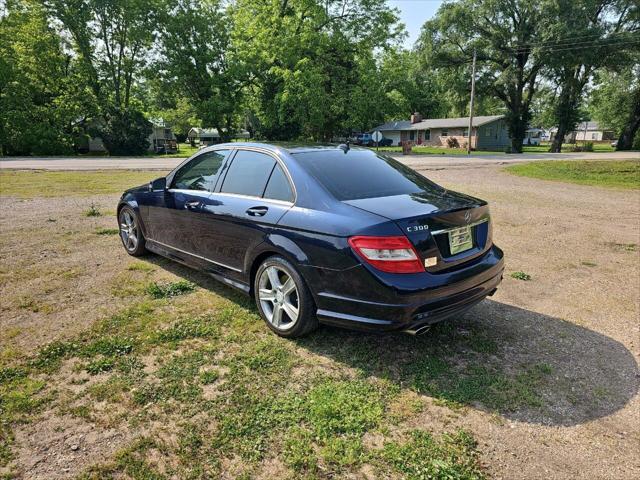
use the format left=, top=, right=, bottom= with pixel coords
left=0, top=0, right=94, bottom=155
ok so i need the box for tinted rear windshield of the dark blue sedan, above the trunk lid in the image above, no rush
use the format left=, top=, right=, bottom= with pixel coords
left=294, top=149, right=441, bottom=200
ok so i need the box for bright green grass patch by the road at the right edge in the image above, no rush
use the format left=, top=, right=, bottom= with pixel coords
left=505, top=160, right=640, bottom=189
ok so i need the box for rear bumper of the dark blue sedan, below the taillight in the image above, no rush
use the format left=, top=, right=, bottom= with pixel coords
left=307, top=246, right=504, bottom=331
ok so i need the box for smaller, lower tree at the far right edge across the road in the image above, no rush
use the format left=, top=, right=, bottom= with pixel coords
left=589, top=61, right=640, bottom=150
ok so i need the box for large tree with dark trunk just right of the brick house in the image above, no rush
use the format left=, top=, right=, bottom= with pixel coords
left=420, top=0, right=551, bottom=152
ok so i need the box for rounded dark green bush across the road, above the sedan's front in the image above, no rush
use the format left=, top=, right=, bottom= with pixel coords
left=98, top=109, right=152, bottom=155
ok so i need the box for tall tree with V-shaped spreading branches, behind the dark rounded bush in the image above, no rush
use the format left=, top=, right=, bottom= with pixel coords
left=42, top=0, right=159, bottom=153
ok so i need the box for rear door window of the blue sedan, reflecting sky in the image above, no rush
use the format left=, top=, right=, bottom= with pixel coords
left=220, top=150, right=276, bottom=197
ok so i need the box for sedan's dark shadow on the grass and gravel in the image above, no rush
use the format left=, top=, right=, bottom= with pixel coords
left=148, top=256, right=640, bottom=426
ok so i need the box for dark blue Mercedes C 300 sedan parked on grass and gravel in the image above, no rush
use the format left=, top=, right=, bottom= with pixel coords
left=118, top=143, right=504, bottom=337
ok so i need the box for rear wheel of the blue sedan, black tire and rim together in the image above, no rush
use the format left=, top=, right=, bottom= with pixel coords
left=253, top=255, right=318, bottom=338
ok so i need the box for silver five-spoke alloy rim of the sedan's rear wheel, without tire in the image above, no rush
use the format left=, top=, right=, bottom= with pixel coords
left=258, top=265, right=300, bottom=331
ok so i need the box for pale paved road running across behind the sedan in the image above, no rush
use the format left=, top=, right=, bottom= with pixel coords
left=0, top=152, right=640, bottom=170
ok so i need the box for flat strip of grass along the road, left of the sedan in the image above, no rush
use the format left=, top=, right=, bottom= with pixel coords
left=0, top=170, right=170, bottom=198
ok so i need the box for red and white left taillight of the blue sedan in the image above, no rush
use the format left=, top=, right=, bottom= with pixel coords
left=349, top=236, right=424, bottom=273
